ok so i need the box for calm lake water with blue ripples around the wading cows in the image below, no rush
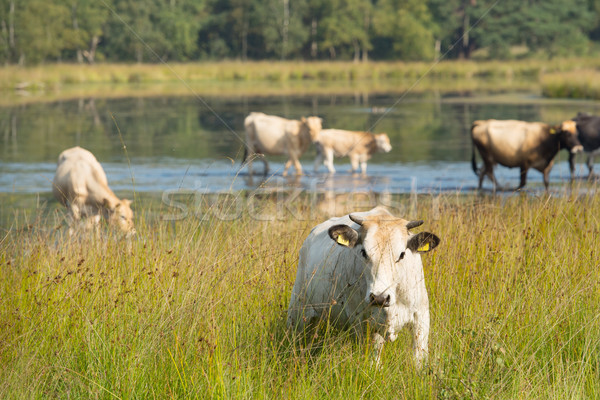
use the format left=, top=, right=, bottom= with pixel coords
left=0, top=93, right=600, bottom=193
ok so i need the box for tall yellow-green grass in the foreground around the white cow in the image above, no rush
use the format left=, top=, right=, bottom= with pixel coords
left=0, top=194, right=600, bottom=399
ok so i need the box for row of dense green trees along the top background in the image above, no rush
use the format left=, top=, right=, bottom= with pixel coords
left=0, top=0, right=600, bottom=65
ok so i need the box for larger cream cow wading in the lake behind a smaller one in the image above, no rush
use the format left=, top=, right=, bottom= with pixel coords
left=244, top=112, right=323, bottom=176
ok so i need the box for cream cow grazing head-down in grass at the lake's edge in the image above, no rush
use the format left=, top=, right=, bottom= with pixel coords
left=52, top=146, right=135, bottom=234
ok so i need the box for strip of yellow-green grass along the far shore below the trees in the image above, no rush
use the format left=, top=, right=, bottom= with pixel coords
left=0, top=59, right=600, bottom=104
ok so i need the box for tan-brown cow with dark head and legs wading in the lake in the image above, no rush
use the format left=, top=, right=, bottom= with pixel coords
left=471, top=119, right=582, bottom=190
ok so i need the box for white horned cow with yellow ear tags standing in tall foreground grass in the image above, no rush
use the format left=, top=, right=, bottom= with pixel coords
left=287, top=207, right=440, bottom=365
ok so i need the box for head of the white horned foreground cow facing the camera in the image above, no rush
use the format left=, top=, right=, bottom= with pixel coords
left=329, top=208, right=440, bottom=308
